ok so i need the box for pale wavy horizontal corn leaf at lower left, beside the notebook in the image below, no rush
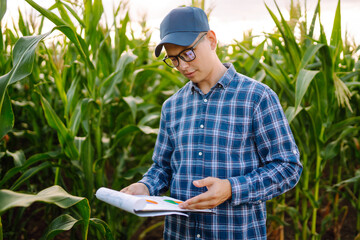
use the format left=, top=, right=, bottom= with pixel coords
left=0, top=186, right=88, bottom=214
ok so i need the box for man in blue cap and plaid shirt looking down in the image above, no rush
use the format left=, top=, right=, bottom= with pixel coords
left=122, top=7, right=302, bottom=240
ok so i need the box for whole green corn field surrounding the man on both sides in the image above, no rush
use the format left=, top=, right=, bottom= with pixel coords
left=0, top=0, right=360, bottom=240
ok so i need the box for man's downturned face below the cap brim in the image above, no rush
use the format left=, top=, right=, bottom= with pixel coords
left=164, top=33, right=211, bottom=83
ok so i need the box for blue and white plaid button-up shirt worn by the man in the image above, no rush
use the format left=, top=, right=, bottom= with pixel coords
left=140, top=64, right=302, bottom=240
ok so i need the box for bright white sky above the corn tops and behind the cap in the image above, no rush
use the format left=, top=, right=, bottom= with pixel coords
left=2, top=0, right=360, bottom=45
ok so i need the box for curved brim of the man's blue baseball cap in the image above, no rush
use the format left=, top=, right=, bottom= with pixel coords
left=155, top=32, right=200, bottom=57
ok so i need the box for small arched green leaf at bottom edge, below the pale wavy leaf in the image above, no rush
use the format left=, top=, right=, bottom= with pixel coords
left=45, top=214, right=79, bottom=239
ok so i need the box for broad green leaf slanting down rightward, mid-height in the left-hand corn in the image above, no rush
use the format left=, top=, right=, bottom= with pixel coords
left=40, top=95, right=79, bottom=160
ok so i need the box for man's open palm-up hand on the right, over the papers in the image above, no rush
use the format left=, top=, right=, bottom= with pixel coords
left=179, top=177, right=231, bottom=209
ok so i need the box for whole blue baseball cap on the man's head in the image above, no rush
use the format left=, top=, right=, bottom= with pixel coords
left=155, top=7, right=210, bottom=57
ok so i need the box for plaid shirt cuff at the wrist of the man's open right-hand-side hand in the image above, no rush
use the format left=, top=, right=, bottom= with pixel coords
left=228, top=176, right=249, bottom=206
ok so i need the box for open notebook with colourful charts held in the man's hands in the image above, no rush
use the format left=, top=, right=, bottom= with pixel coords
left=95, top=187, right=213, bottom=217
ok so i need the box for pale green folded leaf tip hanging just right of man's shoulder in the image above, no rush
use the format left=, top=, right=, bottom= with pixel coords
left=295, top=69, right=319, bottom=111
